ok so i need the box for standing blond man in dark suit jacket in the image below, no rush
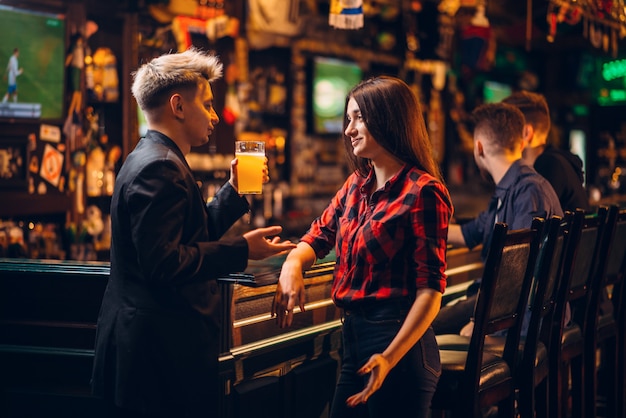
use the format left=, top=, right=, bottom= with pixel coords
left=92, top=49, right=295, bottom=417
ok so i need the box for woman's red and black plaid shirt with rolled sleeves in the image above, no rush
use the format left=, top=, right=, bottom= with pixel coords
left=302, top=165, right=452, bottom=308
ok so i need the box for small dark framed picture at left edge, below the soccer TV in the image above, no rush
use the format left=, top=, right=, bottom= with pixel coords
left=0, top=138, right=29, bottom=189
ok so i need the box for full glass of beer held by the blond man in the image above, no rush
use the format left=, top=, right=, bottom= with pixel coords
left=235, top=141, right=265, bottom=194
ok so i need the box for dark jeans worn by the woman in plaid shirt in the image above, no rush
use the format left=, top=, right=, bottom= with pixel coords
left=330, top=303, right=441, bottom=418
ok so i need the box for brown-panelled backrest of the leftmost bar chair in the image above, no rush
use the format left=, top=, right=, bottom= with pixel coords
left=464, top=222, right=540, bottom=396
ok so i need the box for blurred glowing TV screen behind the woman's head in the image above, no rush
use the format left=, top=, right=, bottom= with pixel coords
left=310, top=57, right=363, bottom=135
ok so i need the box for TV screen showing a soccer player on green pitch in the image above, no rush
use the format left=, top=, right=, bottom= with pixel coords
left=0, top=5, right=66, bottom=121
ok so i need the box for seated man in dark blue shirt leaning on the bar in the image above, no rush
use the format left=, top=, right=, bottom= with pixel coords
left=433, top=103, right=563, bottom=334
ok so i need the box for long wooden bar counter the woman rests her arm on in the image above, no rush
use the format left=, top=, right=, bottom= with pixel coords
left=0, top=249, right=482, bottom=418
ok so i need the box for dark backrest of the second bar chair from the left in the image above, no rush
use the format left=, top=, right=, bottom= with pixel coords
left=522, top=216, right=571, bottom=370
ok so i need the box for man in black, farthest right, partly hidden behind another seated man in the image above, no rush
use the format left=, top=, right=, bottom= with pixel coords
left=503, top=91, right=589, bottom=211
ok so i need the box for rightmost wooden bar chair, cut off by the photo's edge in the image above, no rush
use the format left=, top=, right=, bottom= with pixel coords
left=584, top=206, right=626, bottom=417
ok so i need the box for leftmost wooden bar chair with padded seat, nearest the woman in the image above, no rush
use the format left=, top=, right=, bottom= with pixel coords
left=432, top=223, right=540, bottom=418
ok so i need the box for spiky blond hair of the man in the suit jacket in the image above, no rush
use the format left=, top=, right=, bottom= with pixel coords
left=131, top=47, right=223, bottom=110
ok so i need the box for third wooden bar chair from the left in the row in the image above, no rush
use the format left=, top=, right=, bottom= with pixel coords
left=548, top=207, right=608, bottom=418
